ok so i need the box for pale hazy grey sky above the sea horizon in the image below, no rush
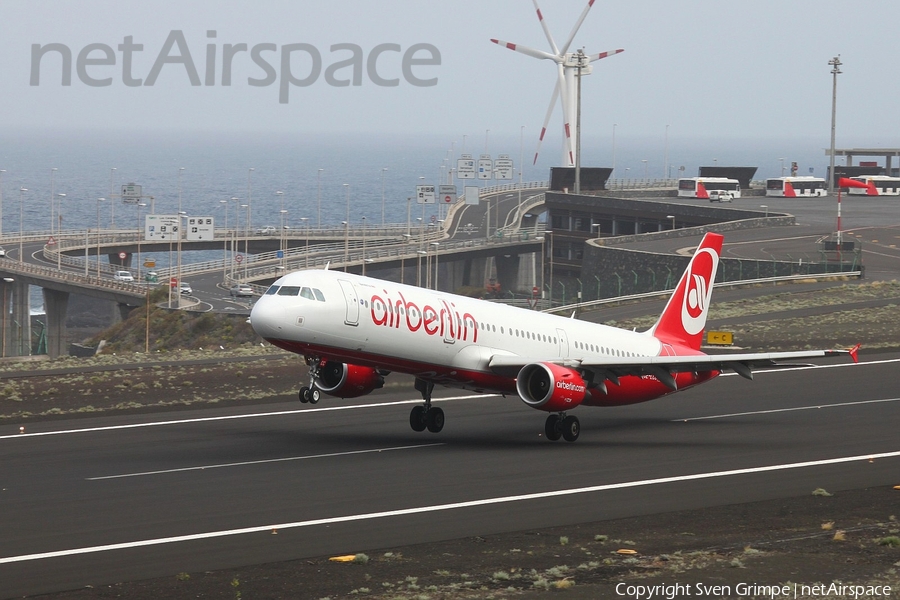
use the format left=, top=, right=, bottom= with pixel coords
left=0, top=0, right=900, bottom=146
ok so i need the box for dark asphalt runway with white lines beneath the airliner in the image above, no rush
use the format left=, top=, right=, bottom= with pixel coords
left=0, top=354, right=900, bottom=598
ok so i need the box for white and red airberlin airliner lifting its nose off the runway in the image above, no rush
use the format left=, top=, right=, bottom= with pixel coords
left=250, top=233, right=858, bottom=441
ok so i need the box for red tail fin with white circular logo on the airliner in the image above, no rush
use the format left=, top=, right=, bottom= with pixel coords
left=649, top=233, right=724, bottom=350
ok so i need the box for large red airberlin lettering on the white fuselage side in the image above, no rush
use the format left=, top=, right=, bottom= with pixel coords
left=370, top=290, right=478, bottom=343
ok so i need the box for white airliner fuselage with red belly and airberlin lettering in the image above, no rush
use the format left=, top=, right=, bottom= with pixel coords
left=251, top=270, right=716, bottom=405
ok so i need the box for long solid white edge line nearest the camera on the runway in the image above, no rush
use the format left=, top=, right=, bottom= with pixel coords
left=0, top=451, right=900, bottom=564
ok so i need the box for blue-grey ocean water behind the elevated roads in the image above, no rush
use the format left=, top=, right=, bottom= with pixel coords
left=0, top=130, right=873, bottom=305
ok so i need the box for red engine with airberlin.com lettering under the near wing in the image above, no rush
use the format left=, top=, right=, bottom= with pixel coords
left=516, top=363, right=588, bottom=412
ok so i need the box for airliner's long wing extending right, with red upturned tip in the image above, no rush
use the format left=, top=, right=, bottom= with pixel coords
left=488, top=347, right=858, bottom=389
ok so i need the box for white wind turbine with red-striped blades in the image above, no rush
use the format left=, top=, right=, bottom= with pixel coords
left=491, top=0, right=624, bottom=167
